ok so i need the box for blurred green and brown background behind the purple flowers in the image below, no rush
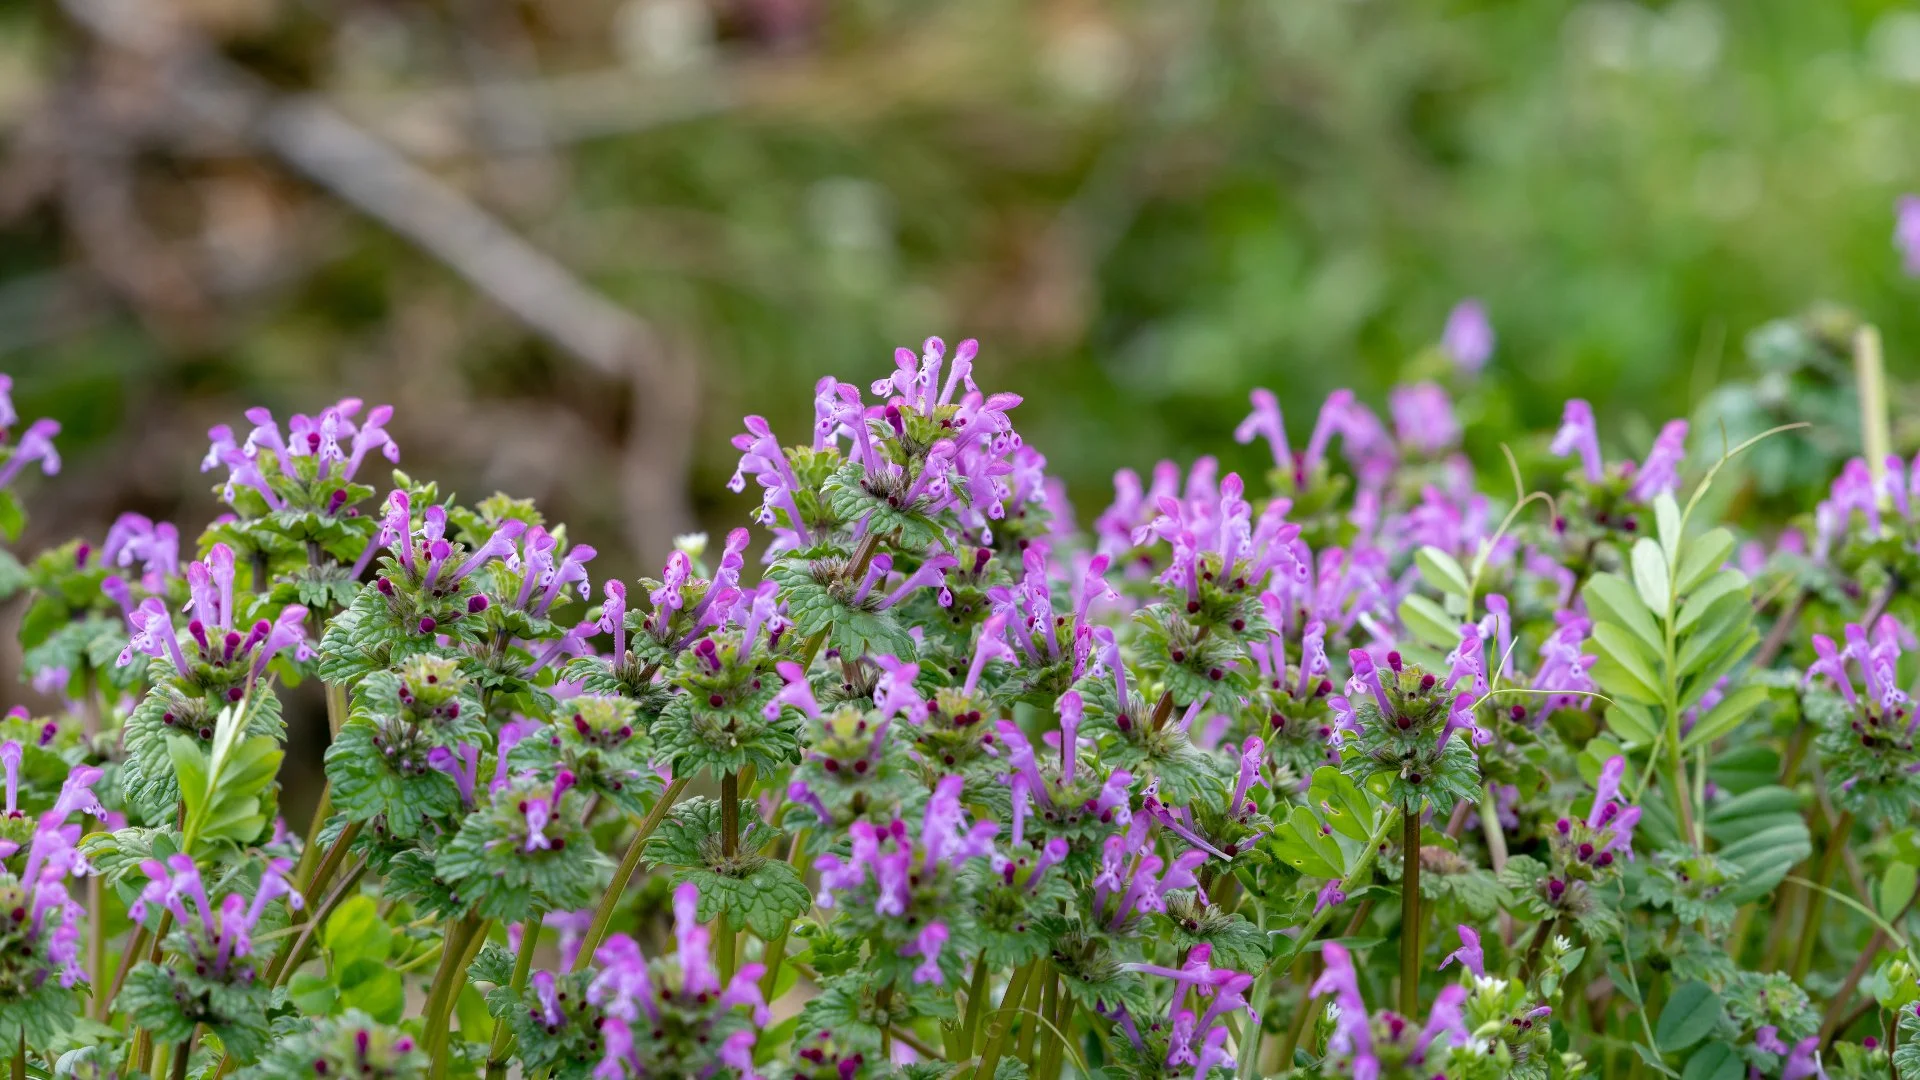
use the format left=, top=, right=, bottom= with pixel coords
left=0, top=0, right=1920, bottom=577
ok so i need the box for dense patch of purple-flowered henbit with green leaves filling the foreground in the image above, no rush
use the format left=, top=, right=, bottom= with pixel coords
left=0, top=288, right=1920, bottom=1080
